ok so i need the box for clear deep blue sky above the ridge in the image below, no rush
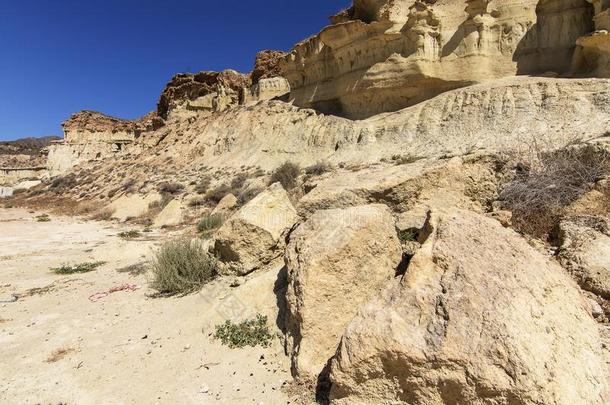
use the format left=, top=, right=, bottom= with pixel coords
left=0, top=0, right=351, bottom=140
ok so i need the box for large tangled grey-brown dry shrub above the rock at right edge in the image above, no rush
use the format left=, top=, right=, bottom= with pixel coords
left=500, top=145, right=610, bottom=237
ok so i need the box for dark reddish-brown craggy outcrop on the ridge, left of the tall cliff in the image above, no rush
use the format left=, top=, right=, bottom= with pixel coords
left=157, top=69, right=251, bottom=119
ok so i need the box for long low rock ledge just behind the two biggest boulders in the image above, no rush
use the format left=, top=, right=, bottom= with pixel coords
left=298, top=158, right=497, bottom=215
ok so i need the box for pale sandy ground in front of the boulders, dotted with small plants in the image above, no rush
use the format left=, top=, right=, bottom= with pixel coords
left=0, top=209, right=291, bottom=404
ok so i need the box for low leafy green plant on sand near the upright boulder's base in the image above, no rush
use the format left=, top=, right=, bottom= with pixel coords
left=214, top=314, right=273, bottom=349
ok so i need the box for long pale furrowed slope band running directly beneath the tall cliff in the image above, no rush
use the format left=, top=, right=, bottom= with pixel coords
left=142, top=77, right=610, bottom=169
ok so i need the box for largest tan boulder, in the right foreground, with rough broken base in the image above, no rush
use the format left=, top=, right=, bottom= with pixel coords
left=330, top=209, right=609, bottom=404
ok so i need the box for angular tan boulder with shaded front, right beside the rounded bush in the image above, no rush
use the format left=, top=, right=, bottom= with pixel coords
left=214, top=183, right=298, bottom=275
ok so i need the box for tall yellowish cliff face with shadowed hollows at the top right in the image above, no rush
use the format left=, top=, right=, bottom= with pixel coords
left=281, top=0, right=606, bottom=119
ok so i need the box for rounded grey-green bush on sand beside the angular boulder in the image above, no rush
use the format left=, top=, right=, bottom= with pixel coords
left=151, top=238, right=218, bottom=294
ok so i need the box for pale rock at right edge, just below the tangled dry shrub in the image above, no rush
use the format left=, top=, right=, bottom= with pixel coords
left=558, top=216, right=610, bottom=299
